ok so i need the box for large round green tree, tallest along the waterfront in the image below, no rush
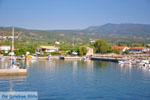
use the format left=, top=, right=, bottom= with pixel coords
left=94, top=40, right=107, bottom=53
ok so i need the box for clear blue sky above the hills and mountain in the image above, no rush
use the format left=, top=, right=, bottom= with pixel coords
left=0, top=0, right=150, bottom=30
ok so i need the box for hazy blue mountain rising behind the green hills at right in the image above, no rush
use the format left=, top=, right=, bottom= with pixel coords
left=87, top=23, right=150, bottom=37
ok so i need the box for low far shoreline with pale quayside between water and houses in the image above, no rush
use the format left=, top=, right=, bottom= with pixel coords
left=1, top=54, right=150, bottom=62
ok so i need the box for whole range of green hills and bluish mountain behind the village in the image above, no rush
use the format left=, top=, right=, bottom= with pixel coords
left=0, top=24, right=150, bottom=43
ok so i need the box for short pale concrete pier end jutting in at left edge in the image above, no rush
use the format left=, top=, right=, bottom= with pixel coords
left=0, top=69, right=27, bottom=76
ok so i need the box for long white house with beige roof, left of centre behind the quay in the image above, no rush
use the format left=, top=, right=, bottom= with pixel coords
left=37, top=46, right=59, bottom=52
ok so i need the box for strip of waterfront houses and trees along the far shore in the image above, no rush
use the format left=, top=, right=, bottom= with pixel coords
left=0, top=40, right=150, bottom=56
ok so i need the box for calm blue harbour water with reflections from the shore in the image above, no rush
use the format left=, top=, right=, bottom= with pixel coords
left=0, top=60, right=150, bottom=100
